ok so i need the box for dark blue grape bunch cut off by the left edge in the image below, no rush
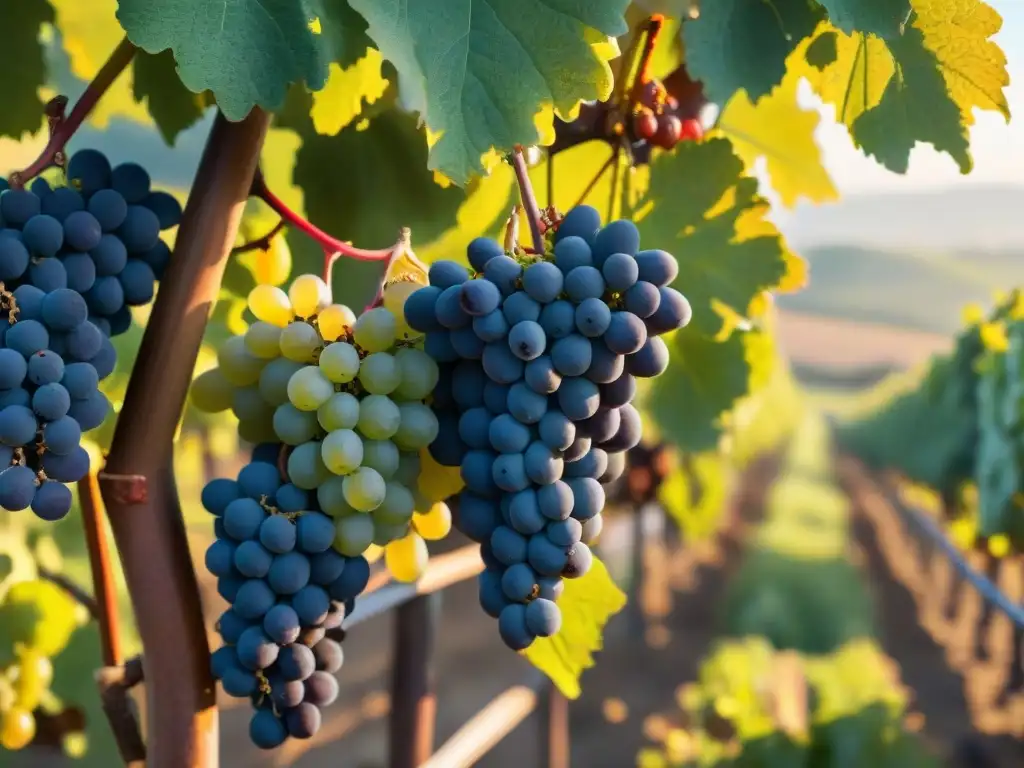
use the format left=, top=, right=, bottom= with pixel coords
left=0, top=150, right=181, bottom=520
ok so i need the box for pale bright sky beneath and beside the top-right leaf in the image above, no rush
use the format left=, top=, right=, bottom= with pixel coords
left=806, top=0, right=1024, bottom=195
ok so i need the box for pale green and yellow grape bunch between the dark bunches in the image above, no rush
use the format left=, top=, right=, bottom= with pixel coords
left=193, top=275, right=451, bottom=581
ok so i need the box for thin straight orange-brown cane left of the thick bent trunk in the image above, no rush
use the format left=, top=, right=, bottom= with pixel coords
left=78, top=472, right=124, bottom=667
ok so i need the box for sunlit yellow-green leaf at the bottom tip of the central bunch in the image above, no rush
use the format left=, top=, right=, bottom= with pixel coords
left=524, top=556, right=626, bottom=698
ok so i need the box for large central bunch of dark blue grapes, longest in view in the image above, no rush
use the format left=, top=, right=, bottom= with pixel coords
left=406, top=206, right=690, bottom=650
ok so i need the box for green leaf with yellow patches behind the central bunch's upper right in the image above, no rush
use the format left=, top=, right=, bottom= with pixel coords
left=634, top=138, right=787, bottom=336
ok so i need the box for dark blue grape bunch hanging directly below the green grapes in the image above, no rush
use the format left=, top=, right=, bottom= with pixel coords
left=202, top=443, right=370, bottom=750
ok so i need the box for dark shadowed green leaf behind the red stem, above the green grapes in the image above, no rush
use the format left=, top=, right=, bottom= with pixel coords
left=287, top=99, right=466, bottom=307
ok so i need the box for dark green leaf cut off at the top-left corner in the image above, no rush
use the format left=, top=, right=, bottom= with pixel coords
left=0, top=0, right=53, bottom=139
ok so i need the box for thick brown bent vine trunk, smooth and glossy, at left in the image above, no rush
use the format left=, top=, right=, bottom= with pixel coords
left=99, top=109, right=269, bottom=768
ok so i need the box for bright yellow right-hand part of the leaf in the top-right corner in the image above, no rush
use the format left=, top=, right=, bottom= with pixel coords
left=911, top=0, right=1010, bottom=125
